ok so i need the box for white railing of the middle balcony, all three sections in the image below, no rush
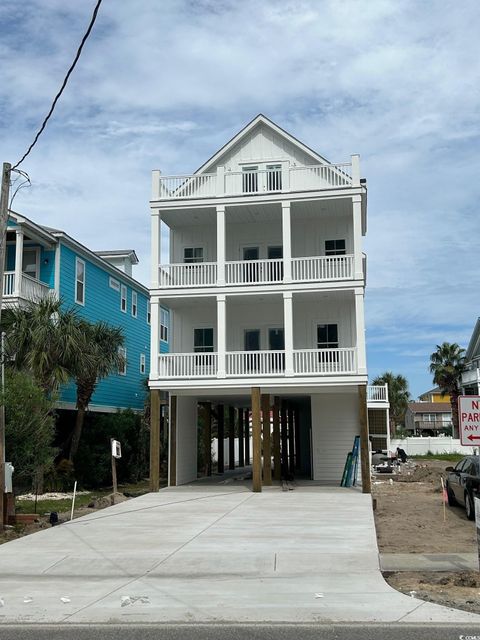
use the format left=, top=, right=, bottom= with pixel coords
left=159, top=255, right=354, bottom=288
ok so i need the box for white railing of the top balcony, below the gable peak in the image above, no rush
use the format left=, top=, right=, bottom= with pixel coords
left=152, top=156, right=360, bottom=200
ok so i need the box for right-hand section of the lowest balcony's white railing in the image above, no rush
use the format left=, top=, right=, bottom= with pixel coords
left=293, top=347, right=356, bottom=375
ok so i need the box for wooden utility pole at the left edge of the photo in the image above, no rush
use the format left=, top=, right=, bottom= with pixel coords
left=0, top=162, right=12, bottom=531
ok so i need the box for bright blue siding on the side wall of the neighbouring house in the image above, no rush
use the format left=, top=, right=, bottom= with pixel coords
left=60, top=243, right=153, bottom=409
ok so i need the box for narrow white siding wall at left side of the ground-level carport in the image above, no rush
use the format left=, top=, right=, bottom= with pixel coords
left=177, top=396, right=197, bottom=485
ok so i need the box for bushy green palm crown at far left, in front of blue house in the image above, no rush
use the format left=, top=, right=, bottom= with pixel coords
left=2, top=298, right=82, bottom=395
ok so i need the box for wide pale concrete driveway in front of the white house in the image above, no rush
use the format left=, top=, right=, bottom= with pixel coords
left=0, top=485, right=480, bottom=623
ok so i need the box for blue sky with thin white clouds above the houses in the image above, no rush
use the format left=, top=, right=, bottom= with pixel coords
left=0, top=0, right=480, bottom=397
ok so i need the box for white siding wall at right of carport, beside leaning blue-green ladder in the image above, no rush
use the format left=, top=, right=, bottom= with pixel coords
left=312, top=389, right=360, bottom=485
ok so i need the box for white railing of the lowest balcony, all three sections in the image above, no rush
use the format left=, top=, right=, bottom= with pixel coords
left=159, top=347, right=357, bottom=380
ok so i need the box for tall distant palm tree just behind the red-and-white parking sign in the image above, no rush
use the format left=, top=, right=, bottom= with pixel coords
left=430, top=342, right=465, bottom=438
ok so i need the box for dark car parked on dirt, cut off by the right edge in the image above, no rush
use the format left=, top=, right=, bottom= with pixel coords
left=445, top=456, right=480, bottom=520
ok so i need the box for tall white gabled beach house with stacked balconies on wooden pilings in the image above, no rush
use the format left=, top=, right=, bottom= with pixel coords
left=150, top=115, right=386, bottom=490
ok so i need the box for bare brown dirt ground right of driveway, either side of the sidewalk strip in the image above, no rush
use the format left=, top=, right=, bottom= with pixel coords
left=372, top=460, right=480, bottom=613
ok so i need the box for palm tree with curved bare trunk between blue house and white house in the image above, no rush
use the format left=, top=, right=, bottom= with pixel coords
left=68, top=320, right=125, bottom=461
